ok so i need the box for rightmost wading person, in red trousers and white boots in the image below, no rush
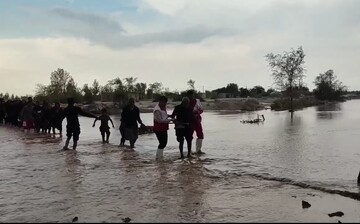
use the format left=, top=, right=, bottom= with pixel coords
left=187, top=90, right=204, bottom=154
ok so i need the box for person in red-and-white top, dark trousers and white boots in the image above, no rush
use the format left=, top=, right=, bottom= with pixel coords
left=153, top=96, right=173, bottom=160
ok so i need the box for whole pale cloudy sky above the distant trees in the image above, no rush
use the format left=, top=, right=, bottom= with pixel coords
left=0, top=0, right=360, bottom=95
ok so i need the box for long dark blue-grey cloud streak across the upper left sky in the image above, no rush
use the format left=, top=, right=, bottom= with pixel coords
left=47, top=8, right=233, bottom=48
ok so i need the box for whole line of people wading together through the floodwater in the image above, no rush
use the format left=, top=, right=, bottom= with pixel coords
left=0, top=90, right=204, bottom=159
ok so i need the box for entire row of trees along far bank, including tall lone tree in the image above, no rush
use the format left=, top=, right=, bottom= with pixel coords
left=0, top=47, right=352, bottom=109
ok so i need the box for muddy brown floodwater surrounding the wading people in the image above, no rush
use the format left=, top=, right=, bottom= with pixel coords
left=0, top=100, right=360, bottom=222
